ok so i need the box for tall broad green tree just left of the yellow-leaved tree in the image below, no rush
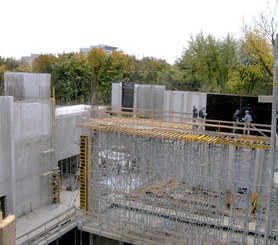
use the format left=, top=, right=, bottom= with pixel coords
left=176, top=32, right=238, bottom=93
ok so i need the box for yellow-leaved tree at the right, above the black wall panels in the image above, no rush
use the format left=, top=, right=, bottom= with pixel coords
left=228, top=27, right=273, bottom=95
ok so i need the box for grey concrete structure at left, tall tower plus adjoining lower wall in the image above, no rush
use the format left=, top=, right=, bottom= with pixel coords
left=0, top=73, right=87, bottom=217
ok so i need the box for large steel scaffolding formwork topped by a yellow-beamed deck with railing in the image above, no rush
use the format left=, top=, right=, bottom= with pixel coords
left=78, top=108, right=278, bottom=244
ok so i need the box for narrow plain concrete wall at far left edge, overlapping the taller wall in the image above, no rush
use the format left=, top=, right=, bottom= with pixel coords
left=0, top=96, right=16, bottom=215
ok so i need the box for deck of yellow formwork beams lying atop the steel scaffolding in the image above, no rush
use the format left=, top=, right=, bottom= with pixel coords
left=78, top=118, right=270, bottom=150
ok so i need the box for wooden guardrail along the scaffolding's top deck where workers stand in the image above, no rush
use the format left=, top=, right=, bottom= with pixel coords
left=84, top=106, right=271, bottom=137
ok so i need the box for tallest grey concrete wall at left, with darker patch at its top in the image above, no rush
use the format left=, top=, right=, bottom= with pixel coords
left=1, top=73, right=53, bottom=216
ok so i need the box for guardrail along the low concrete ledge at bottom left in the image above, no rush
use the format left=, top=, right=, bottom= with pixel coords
left=16, top=206, right=76, bottom=245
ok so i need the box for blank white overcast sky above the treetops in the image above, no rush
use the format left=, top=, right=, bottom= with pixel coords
left=0, top=0, right=268, bottom=64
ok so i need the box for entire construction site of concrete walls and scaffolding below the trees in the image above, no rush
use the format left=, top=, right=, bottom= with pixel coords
left=0, top=73, right=278, bottom=245
